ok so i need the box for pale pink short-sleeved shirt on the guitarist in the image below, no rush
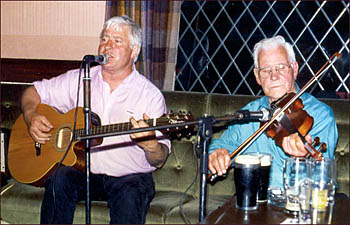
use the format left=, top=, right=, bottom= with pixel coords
left=34, top=66, right=170, bottom=177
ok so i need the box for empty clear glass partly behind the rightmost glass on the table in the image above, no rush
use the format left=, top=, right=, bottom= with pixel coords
left=283, top=157, right=311, bottom=216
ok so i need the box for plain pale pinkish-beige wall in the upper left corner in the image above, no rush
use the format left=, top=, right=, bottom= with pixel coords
left=1, top=1, right=106, bottom=60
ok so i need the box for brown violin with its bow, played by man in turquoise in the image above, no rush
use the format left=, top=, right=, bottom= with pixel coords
left=208, top=52, right=341, bottom=182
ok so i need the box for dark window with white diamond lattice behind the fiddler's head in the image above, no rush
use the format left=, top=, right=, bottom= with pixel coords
left=175, top=1, right=350, bottom=97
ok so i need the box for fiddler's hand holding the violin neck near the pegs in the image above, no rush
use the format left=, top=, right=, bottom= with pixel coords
left=282, top=133, right=312, bottom=156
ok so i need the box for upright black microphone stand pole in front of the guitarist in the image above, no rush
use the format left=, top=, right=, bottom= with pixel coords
left=83, top=60, right=91, bottom=224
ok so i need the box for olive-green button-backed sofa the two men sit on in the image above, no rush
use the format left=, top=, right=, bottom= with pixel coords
left=1, top=85, right=349, bottom=224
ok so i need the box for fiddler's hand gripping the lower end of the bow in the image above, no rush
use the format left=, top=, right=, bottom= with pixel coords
left=208, top=148, right=231, bottom=176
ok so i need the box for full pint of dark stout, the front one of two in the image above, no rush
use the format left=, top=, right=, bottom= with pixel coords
left=234, top=155, right=260, bottom=210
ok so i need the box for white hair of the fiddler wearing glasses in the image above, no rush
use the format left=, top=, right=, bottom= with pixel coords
left=253, top=35, right=295, bottom=68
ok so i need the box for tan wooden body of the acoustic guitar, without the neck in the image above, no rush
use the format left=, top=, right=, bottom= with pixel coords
left=8, top=104, right=98, bottom=186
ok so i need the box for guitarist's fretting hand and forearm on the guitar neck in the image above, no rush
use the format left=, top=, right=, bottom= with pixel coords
left=130, top=113, right=169, bottom=168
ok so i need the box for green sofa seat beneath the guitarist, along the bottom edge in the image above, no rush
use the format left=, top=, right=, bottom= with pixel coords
left=1, top=181, right=198, bottom=224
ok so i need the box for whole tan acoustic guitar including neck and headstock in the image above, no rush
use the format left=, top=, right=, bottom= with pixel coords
left=8, top=104, right=193, bottom=187
